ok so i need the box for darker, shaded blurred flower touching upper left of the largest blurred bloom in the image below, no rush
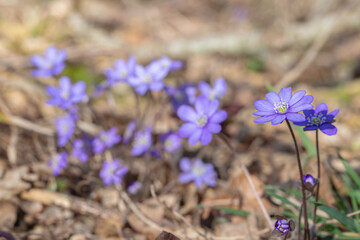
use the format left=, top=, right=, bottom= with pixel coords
left=165, top=83, right=197, bottom=111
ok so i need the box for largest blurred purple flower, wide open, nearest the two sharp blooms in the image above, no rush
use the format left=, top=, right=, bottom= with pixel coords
left=177, top=96, right=227, bottom=145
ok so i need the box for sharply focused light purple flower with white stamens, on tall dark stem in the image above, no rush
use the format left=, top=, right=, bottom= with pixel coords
left=253, top=87, right=314, bottom=125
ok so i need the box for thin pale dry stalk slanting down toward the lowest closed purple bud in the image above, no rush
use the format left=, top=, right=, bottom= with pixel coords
left=220, top=133, right=274, bottom=229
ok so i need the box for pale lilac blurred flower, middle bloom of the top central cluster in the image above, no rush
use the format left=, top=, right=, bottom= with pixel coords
left=128, top=63, right=167, bottom=95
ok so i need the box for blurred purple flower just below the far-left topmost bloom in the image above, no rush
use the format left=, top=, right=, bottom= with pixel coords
left=46, top=77, right=87, bottom=109
